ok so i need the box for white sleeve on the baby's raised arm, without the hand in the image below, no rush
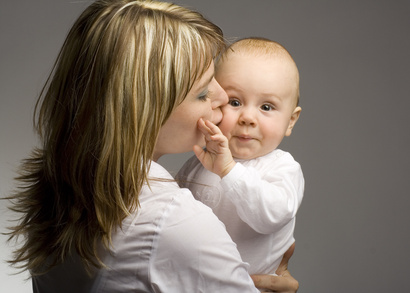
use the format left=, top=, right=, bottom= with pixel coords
left=221, top=153, right=304, bottom=234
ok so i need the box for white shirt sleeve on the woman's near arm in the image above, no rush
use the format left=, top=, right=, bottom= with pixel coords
left=150, top=190, right=259, bottom=293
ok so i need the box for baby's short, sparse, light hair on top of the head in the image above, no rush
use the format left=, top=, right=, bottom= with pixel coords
left=216, top=37, right=300, bottom=106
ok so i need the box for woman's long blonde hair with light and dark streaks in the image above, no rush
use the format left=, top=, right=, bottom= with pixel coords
left=9, top=0, right=225, bottom=275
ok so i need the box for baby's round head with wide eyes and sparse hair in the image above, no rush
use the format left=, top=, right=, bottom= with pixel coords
left=215, top=38, right=302, bottom=159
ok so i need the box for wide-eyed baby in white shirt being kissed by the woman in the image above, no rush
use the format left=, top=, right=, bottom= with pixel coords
left=177, top=38, right=304, bottom=274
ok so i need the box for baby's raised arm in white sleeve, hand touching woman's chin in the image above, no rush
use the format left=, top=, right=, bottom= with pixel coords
left=194, top=119, right=304, bottom=234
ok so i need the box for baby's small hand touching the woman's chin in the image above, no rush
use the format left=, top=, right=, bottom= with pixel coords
left=194, top=118, right=236, bottom=178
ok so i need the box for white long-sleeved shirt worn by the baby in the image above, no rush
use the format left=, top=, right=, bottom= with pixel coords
left=177, top=150, right=304, bottom=274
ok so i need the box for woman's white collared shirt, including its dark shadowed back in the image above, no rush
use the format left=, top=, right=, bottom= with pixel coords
left=33, top=162, right=259, bottom=293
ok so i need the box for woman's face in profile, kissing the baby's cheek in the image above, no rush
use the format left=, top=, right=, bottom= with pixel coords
left=154, top=62, right=228, bottom=161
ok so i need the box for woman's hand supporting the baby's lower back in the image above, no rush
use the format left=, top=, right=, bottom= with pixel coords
left=251, top=243, right=299, bottom=293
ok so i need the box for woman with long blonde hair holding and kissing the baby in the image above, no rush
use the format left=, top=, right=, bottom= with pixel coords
left=11, top=0, right=297, bottom=292
